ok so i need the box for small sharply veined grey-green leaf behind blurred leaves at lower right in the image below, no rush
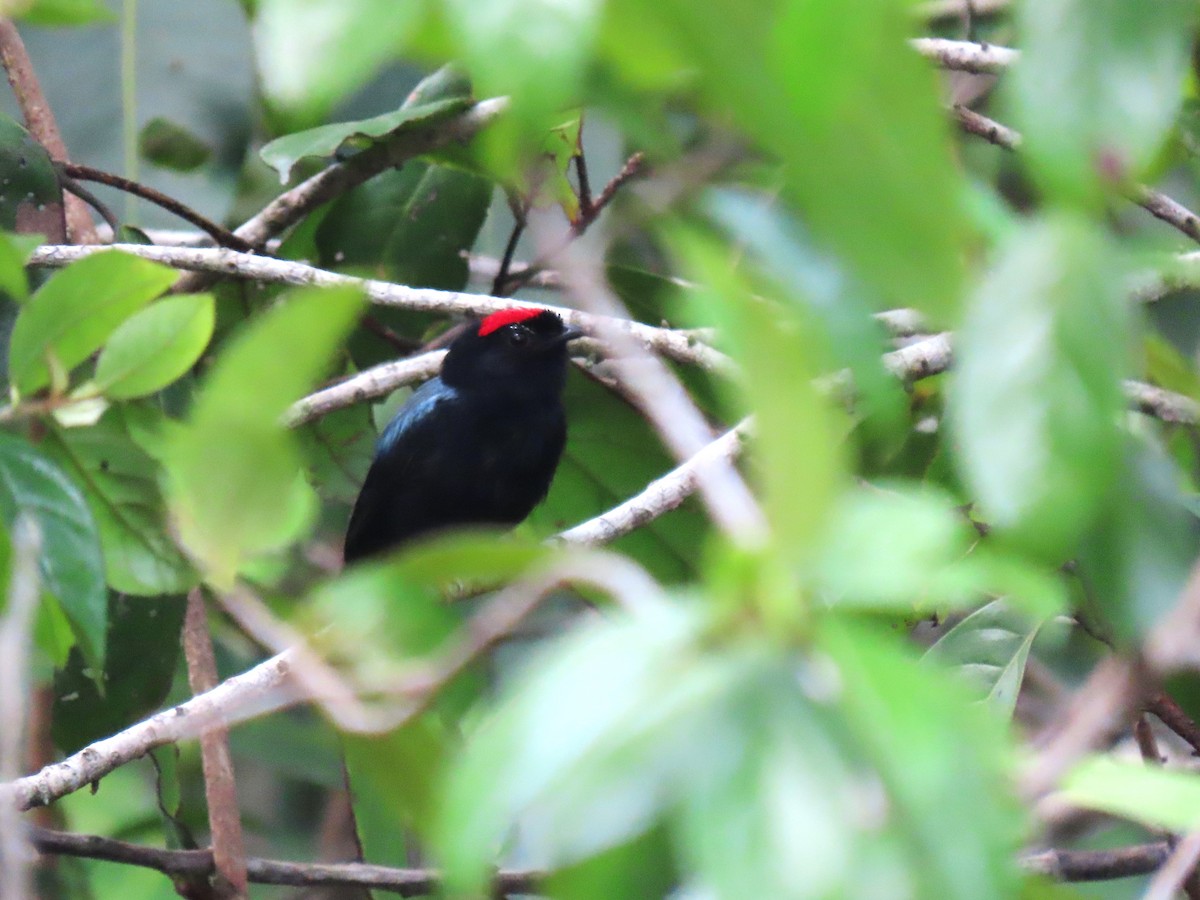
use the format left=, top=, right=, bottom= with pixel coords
left=925, top=600, right=1042, bottom=716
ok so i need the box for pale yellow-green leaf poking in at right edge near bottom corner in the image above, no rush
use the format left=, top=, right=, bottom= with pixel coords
left=1058, top=756, right=1200, bottom=833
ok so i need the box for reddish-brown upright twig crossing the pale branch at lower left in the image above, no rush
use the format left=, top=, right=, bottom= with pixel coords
left=182, top=588, right=246, bottom=898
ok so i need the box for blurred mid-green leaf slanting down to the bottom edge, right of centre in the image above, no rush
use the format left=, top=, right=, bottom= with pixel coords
left=818, top=619, right=1021, bottom=900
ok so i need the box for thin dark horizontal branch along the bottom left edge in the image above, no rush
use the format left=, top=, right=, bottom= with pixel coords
left=30, top=826, right=545, bottom=896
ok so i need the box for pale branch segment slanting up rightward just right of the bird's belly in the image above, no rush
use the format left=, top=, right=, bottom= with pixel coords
left=557, top=420, right=750, bottom=545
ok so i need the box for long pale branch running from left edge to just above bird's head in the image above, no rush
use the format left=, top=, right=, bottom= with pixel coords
left=29, top=244, right=732, bottom=372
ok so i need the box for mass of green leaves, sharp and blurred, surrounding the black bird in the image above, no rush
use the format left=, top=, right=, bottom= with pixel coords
left=7, top=0, right=1200, bottom=899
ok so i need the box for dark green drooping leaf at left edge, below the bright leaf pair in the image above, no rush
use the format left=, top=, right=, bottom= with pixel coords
left=0, top=432, right=108, bottom=671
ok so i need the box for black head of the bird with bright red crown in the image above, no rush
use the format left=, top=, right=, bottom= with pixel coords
left=442, top=306, right=583, bottom=391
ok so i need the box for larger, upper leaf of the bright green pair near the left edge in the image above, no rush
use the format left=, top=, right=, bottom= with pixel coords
left=8, top=251, right=176, bottom=395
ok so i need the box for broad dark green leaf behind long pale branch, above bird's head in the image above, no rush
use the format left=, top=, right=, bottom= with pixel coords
left=317, top=163, right=492, bottom=285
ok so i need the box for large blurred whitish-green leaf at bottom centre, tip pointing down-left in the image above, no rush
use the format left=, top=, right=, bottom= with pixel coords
left=434, top=608, right=737, bottom=894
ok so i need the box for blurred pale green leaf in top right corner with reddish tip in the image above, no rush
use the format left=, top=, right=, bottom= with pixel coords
left=1006, top=0, right=1196, bottom=198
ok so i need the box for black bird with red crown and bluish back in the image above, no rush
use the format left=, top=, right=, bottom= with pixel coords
left=344, top=307, right=581, bottom=563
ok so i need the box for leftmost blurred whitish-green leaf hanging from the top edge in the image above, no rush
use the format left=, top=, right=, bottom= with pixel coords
left=254, top=0, right=421, bottom=125
